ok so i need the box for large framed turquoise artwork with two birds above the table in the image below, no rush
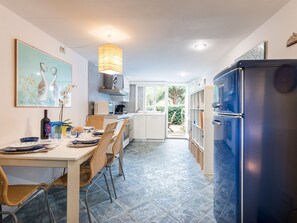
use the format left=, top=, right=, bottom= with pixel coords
left=15, top=40, right=72, bottom=107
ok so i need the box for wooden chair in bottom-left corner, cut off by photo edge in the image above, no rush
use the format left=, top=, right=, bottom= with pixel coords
left=0, top=166, right=52, bottom=223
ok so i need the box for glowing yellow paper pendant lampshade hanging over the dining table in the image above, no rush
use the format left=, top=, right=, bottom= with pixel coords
left=98, top=43, right=123, bottom=75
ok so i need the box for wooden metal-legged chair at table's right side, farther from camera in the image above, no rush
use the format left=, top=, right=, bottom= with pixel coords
left=106, top=119, right=129, bottom=199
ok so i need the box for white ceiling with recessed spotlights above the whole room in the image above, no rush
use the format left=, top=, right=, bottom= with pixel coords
left=0, top=0, right=289, bottom=82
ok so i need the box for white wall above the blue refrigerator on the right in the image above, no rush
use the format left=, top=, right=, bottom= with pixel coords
left=207, top=0, right=297, bottom=80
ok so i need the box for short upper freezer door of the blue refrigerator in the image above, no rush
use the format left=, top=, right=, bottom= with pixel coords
left=213, top=69, right=243, bottom=114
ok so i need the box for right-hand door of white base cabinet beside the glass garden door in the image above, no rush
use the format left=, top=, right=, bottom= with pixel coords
left=146, top=115, right=165, bottom=139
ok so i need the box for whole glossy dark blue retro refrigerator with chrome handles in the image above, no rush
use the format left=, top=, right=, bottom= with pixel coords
left=213, top=60, right=297, bottom=223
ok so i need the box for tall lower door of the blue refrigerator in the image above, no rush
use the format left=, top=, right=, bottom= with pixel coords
left=213, top=116, right=242, bottom=223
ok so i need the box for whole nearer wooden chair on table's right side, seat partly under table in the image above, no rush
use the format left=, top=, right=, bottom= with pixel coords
left=49, top=122, right=117, bottom=223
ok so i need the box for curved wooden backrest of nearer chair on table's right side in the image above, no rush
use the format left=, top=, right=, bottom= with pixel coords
left=90, top=122, right=117, bottom=178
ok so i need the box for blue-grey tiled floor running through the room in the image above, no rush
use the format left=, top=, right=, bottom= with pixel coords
left=6, top=139, right=216, bottom=223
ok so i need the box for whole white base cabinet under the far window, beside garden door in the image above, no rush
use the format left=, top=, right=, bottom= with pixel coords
left=134, top=112, right=166, bottom=140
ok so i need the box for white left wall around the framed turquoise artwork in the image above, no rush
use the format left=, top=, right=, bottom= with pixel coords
left=0, top=5, right=88, bottom=183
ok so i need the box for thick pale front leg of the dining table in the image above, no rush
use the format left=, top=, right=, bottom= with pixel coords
left=67, top=161, right=80, bottom=223
